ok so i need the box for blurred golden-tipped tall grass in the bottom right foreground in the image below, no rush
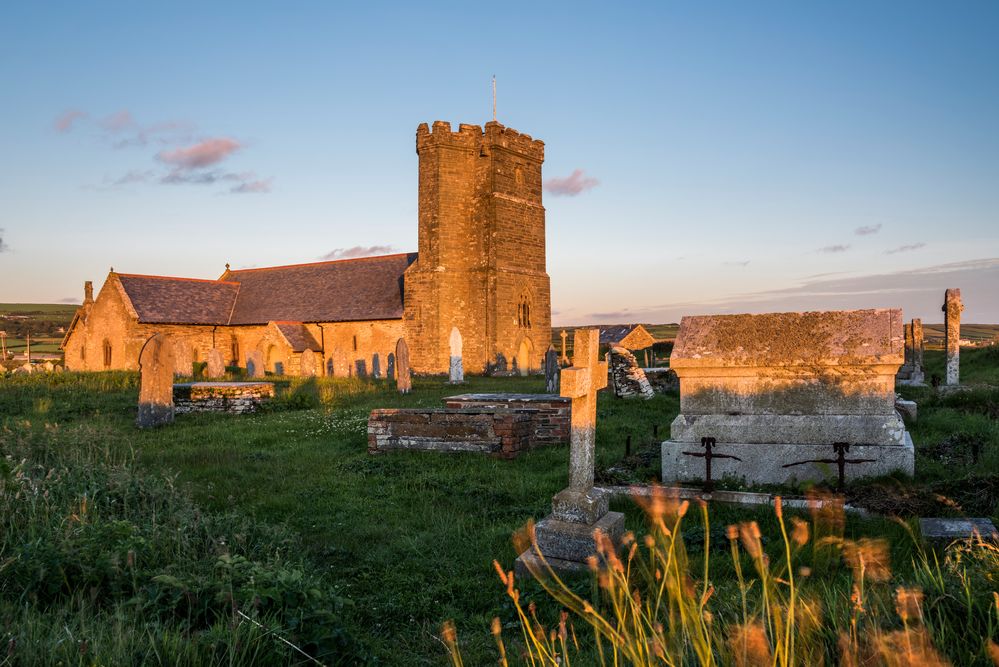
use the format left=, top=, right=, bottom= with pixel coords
left=444, top=489, right=999, bottom=667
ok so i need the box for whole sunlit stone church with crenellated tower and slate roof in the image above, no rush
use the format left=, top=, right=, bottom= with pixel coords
left=62, top=121, right=551, bottom=376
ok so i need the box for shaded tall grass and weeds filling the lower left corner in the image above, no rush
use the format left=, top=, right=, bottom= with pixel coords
left=0, top=421, right=360, bottom=665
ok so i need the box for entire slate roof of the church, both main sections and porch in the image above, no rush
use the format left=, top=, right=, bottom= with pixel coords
left=114, top=253, right=416, bottom=326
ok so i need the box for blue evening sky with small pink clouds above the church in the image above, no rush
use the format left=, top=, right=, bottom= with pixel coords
left=0, top=2, right=999, bottom=323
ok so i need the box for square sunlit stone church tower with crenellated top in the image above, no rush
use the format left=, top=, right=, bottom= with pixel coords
left=404, top=121, right=551, bottom=373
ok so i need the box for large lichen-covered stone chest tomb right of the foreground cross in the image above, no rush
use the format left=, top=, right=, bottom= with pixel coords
left=662, top=309, right=914, bottom=483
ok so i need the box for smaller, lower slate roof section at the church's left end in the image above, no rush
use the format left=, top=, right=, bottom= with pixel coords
left=116, top=273, right=239, bottom=324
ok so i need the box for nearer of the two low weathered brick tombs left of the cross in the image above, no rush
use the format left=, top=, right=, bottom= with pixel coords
left=368, top=409, right=533, bottom=458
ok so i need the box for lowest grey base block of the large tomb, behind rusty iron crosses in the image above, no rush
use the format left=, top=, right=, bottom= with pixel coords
left=662, top=433, right=915, bottom=484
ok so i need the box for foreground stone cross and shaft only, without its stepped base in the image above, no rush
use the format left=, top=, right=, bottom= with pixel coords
left=561, top=329, right=607, bottom=493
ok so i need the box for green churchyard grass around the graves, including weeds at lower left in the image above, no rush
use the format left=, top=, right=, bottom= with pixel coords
left=0, top=348, right=999, bottom=665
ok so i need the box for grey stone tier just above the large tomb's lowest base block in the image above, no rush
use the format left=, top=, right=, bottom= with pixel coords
left=670, top=410, right=905, bottom=446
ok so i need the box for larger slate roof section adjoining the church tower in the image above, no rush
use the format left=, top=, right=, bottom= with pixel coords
left=222, top=253, right=416, bottom=324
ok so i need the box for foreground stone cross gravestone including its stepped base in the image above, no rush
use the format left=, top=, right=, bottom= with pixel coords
left=517, top=329, right=624, bottom=571
